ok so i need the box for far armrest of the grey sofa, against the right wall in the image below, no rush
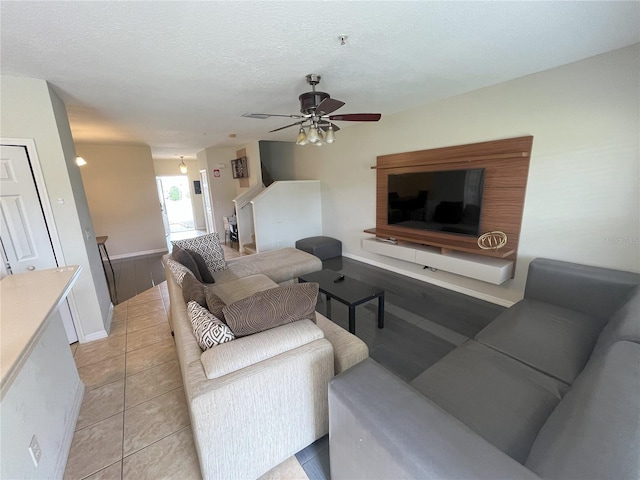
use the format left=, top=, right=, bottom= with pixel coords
left=524, top=258, right=640, bottom=318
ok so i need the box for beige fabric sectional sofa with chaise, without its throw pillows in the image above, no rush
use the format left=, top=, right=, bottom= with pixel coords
left=165, top=249, right=368, bottom=479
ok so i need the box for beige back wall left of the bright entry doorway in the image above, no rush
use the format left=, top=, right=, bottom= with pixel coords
left=76, top=143, right=167, bottom=259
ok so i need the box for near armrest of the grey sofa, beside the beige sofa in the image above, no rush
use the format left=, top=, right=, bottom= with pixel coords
left=329, top=359, right=539, bottom=480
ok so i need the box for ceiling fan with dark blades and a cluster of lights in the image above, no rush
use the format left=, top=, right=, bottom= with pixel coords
left=242, top=73, right=382, bottom=145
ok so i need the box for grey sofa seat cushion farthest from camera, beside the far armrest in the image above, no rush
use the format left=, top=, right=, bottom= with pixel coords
left=475, top=299, right=602, bottom=385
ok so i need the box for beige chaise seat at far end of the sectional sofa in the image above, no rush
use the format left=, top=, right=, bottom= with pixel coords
left=213, top=248, right=322, bottom=283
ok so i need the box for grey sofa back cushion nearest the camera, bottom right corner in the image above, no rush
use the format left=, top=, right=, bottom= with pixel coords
left=525, top=341, right=640, bottom=479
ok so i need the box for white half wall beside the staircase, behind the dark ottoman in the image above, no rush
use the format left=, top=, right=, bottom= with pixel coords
left=251, top=180, right=322, bottom=252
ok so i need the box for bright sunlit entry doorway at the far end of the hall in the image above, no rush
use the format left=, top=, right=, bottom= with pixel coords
left=156, top=175, right=195, bottom=235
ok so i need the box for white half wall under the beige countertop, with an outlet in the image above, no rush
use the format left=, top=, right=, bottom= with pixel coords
left=0, top=310, right=84, bottom=479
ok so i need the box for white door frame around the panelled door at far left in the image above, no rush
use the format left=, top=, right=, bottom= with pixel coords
left=0, top=137, right=85, bottom=343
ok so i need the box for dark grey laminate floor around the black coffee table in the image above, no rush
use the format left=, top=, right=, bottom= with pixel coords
left=296, top=257, right=504, bottom=480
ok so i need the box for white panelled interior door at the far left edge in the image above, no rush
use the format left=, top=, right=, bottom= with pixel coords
left=0, top=145, right=78, bottom=343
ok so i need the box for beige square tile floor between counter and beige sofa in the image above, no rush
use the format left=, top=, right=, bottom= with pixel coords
left=64, top=282, right=307, bottom=480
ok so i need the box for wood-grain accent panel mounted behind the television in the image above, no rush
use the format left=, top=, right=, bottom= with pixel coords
left=369, top=136, right=533, bottom=261
